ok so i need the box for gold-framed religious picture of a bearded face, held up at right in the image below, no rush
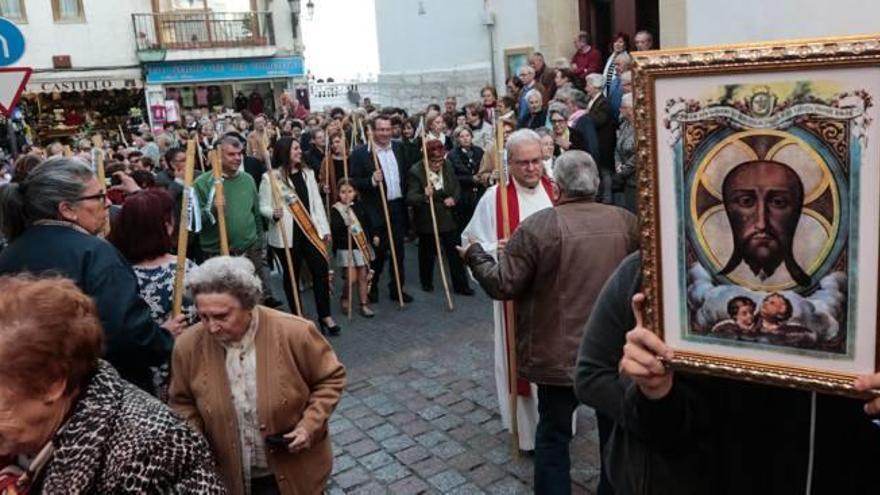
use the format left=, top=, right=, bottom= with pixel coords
left=633, top=37, right=880, bottom=394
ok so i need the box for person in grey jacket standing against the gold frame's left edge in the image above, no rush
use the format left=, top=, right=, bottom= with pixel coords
left=611, top=93, right=636, bottom=213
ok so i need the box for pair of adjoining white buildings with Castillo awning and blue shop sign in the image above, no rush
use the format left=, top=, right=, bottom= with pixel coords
left=0, top=0, right=305, bottom=142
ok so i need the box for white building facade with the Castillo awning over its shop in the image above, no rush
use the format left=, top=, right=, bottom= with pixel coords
left=8, top=0, right=150, bottom=142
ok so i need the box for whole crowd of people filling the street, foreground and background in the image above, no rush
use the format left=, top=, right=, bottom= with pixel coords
left=0, top=26, right=880, bottom=495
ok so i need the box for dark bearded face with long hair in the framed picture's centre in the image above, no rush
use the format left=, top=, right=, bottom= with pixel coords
left=719, top=160, right=812, bottom=287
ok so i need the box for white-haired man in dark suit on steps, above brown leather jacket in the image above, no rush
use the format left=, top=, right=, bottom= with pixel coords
left=586, top=73, right=617, bottom=203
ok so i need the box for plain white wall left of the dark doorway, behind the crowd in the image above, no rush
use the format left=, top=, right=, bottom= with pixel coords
left=375, top=0, right=544, bottom=109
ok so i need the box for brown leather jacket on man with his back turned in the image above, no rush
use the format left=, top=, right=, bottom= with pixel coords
left=465, top=198, right=638, bottom=386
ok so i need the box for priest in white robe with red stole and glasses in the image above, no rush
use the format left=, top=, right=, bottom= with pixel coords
left=462, top=129, right=553, bottom=451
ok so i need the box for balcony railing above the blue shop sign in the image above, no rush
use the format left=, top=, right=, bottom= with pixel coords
left=132, top=11, right=275, bottom=52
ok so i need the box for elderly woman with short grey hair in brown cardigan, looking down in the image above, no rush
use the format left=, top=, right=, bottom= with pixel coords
left=169, top=256, right=345, bottom=495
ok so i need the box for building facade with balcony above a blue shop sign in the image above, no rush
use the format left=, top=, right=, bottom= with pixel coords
left=132, top=0, right=305, bottom=128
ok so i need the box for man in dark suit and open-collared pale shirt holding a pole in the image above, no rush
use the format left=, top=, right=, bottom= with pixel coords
left=351, top=115, right=412, bottom=302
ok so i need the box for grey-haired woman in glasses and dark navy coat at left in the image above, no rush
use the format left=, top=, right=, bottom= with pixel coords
left=0, top=158, right=184, bottom=391
